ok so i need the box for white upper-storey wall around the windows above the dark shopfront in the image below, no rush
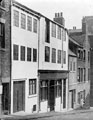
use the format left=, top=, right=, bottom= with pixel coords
left=39, top=17, right=68, bottom=70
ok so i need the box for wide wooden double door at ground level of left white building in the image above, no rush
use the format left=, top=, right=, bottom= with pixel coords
left=13, top=81, right=25, bottom=112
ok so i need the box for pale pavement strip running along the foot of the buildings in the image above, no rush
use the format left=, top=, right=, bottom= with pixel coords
left=0, top=108, right=93, bottom=120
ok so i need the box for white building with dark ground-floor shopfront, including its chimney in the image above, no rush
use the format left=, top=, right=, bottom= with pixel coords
left=38, top=13, right=68, bottom=112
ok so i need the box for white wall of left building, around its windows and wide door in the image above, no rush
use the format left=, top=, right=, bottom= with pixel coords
left=11, top=6, right=38, bottom=113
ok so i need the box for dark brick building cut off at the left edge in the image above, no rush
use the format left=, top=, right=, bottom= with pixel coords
left=0, top=0, right=10, bottom=114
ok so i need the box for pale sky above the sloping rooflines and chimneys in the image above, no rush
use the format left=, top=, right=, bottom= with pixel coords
left=16, top=0, right=93, bottom=29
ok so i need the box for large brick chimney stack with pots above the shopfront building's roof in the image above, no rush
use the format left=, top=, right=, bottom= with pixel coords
left=53, top=12, right=65, bottom=26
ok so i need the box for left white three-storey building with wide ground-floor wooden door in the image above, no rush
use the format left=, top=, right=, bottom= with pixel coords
left=11, top=2, right=39, bottom=113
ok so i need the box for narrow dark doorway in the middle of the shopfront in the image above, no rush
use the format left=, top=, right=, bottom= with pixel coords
left=50, top=80, right=55, bottom=111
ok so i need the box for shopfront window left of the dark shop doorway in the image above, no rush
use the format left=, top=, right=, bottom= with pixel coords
left=40, top=81, right=48, bottom=101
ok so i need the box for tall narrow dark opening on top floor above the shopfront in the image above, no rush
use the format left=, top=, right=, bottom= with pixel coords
left=45, top=19, right=50, bottom=43
